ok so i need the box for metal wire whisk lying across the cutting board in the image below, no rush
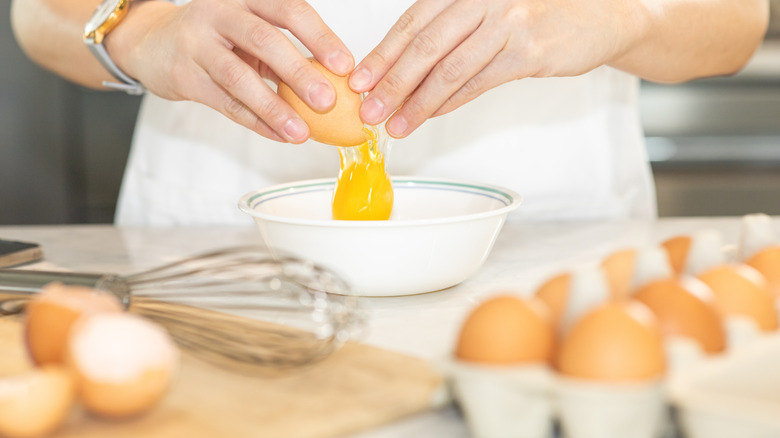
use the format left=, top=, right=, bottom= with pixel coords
left=0, top=246, right=364, bottom=371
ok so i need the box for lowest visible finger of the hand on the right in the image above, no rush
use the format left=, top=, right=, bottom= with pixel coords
left=385, top=26, right=505, bottom=138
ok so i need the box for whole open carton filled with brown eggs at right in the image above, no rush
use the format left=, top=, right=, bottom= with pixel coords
left=444, top=212, right=780, bottom=438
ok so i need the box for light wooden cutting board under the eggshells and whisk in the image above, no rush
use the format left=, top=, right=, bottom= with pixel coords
left=0, top=317, right=443, bottom=438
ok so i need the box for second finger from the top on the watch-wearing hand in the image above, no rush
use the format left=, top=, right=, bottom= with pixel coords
left=216, top=7, right=336, bottom=111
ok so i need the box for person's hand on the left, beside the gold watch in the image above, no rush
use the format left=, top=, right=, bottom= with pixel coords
left=106, top=0, right=354, bottom=143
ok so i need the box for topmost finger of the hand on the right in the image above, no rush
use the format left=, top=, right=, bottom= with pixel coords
left=349, top=0, right=453, bottom=93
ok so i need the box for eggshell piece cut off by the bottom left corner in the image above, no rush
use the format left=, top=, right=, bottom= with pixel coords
left=0, top=365, right=75, bottom=438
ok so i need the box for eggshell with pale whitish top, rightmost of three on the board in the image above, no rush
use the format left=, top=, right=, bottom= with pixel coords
left=68, top=313, right=179, bottom=418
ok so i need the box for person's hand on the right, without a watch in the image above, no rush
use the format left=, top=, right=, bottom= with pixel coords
left=349, top=0, right=642, bottom=137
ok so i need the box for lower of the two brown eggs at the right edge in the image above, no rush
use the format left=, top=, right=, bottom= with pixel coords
left=698, top=264, right=778, bottom=331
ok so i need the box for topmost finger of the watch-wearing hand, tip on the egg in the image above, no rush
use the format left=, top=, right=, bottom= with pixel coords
left=249, top=0, right=355, bottom=76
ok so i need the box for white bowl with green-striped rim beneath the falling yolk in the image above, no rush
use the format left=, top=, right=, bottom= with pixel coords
left=238, top=177, right=521, bottom=296
